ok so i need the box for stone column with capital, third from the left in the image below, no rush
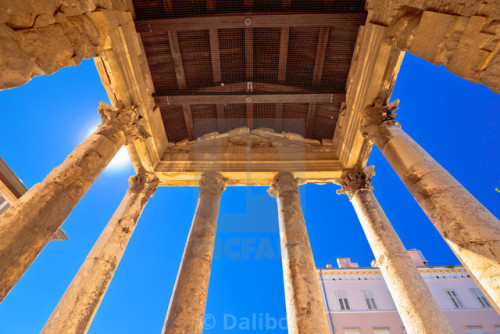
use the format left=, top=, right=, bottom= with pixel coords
left=163, top=173, right=225, bottom=334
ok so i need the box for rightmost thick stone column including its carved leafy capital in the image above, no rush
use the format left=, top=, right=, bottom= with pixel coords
left=361, top=102, right=500, bottom=312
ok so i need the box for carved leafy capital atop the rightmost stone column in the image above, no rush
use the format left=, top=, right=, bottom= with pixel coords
left=361, top=99, right=399, bottom=139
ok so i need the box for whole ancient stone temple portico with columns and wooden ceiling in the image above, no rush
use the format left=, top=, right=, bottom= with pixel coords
left=0, top=0, right=500, bottom=334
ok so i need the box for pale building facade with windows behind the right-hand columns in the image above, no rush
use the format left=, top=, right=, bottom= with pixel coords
left=318, top=250, right=500, bottom=334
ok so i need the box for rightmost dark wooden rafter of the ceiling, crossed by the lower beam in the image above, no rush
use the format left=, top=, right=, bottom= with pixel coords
left=305, top=27, right=330, bottom=138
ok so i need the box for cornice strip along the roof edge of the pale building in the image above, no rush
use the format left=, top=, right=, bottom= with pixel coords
left=317, top=266, right=470, bottom=281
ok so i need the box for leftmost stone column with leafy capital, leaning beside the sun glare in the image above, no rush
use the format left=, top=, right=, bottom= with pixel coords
left=0, top=103, right=146, bottom=302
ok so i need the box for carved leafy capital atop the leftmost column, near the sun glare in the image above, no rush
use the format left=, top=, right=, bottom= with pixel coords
left=98, top=102, right=151, bottom=143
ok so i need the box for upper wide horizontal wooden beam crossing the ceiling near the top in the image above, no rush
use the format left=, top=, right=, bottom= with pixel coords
left=135, top=13, right=366, bottom=34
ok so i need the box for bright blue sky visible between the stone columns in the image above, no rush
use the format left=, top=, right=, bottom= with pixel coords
left=0, top=55, right=500, bottom=334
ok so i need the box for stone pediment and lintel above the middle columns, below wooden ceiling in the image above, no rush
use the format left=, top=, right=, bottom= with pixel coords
left=156, top=127, right=342, bottom=186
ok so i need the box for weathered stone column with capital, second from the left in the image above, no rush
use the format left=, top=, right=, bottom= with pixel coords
left=41, top=173, right=159, bottom=334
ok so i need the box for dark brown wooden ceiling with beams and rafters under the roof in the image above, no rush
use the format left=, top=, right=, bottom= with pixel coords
left=133, top=0, right=366, bottom=142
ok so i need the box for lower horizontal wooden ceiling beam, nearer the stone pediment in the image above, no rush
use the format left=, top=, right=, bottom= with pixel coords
left=161, top=91, right=345, bottom=105
